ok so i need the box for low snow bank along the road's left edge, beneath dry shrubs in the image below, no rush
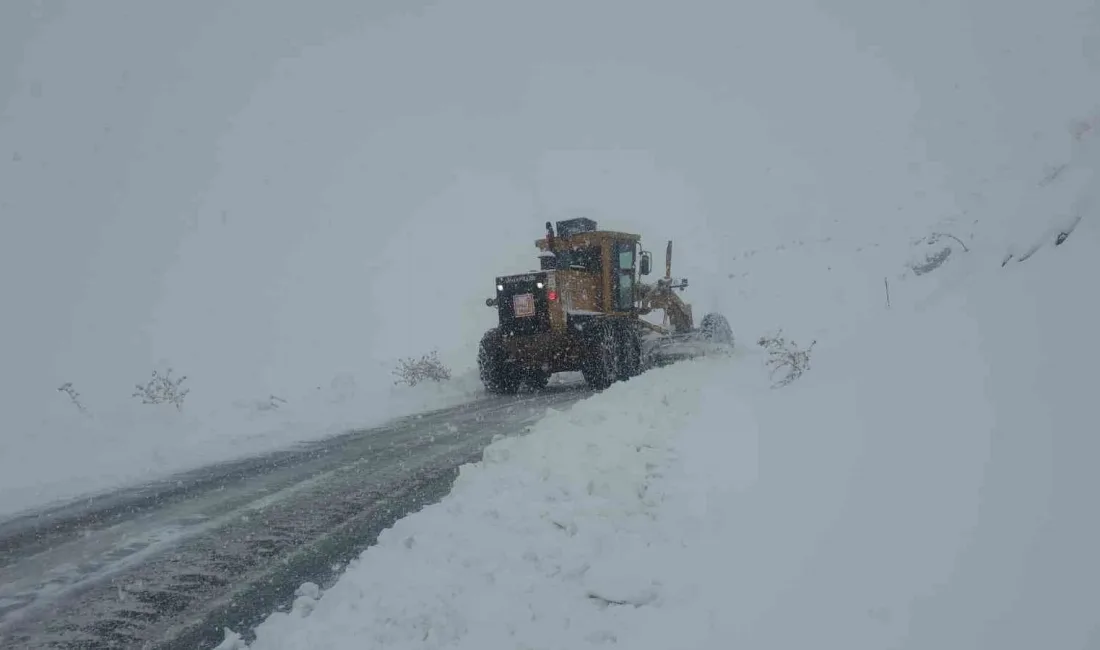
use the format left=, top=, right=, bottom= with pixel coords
left=0, top=372, right=485, bottom=517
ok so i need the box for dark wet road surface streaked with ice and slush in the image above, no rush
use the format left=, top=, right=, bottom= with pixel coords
left=0, top=384, right=590, bottom=649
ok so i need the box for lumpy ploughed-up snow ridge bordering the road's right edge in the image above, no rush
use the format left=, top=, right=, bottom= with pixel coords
left=220, top=356, right=727, bottom=648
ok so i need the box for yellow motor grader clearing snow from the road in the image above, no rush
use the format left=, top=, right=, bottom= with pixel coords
left=477, top=218, right=734, bottom=394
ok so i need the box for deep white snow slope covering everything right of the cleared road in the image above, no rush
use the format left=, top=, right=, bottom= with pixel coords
left=222, top=120, right=1100, bottom=650
